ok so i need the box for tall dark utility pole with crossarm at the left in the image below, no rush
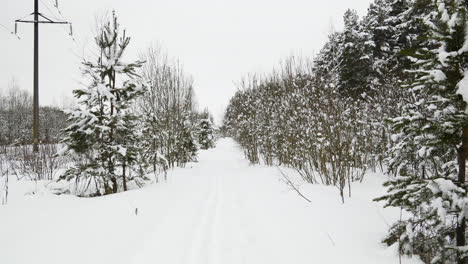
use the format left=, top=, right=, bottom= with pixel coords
left=15, top=0, right=71, bottom=152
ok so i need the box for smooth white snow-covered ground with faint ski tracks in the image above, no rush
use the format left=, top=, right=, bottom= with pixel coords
left=0, top=139, right=420, bottom=264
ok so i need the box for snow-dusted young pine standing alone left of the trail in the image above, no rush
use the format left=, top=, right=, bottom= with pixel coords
left=60, top=13, right=145, bottom=195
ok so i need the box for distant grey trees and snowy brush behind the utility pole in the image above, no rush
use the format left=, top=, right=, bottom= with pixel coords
left=0, top=81, right=67, bottom=191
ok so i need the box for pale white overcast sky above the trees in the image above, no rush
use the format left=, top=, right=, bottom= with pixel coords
left=0, top=0, right=371, bottom=124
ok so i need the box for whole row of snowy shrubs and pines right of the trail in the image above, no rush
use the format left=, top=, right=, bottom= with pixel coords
left=223, top=0, right=468, bottom=263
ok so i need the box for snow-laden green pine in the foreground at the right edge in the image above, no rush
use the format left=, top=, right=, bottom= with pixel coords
left=377, top=0, right=468, bottom=264
